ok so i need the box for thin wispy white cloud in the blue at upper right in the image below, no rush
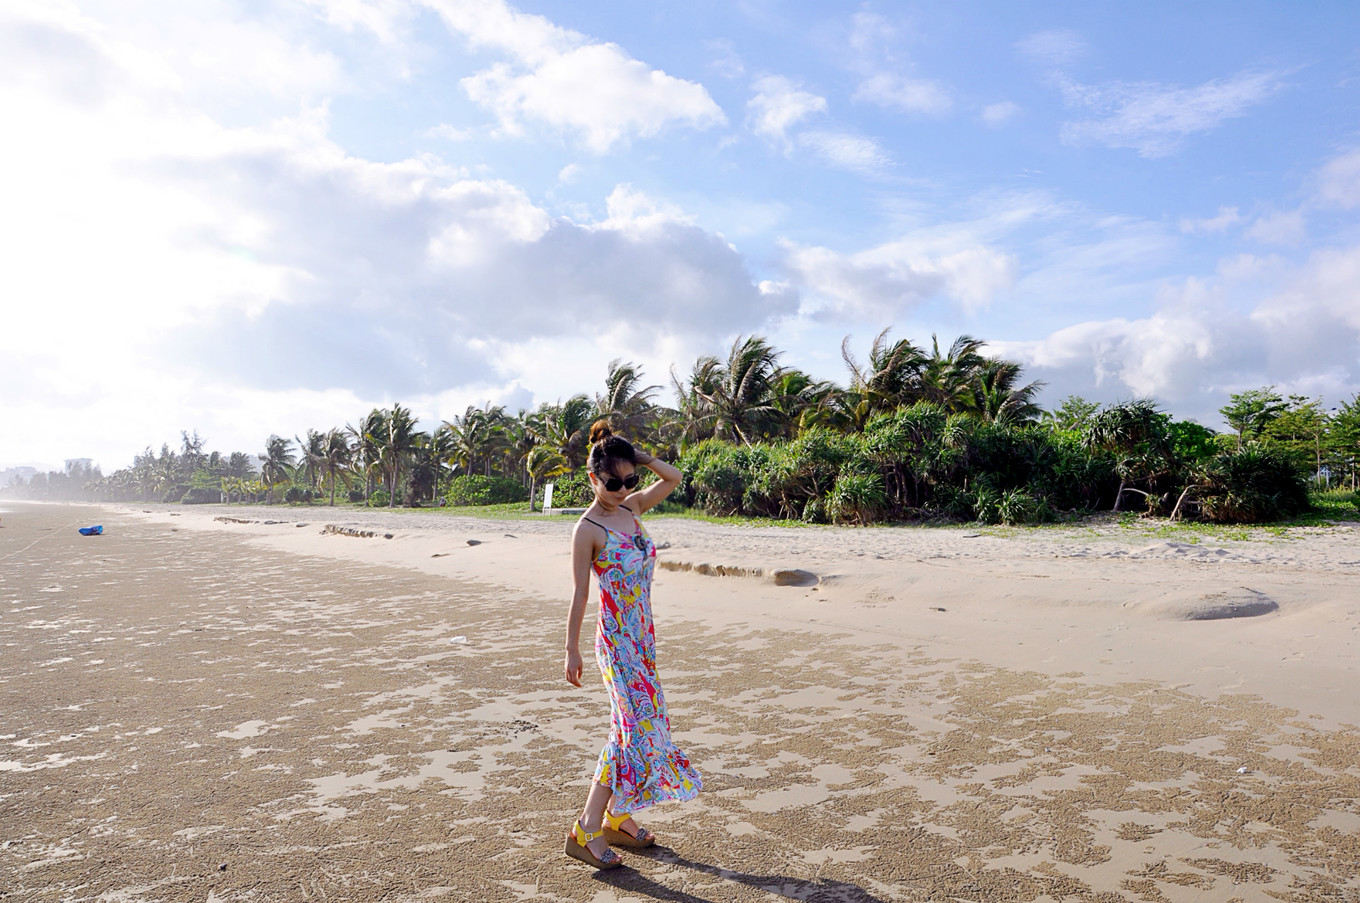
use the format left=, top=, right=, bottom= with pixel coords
left=1059, top=72, right=1284, bottom=158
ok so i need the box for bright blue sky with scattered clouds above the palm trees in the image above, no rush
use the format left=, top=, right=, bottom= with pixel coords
left=0, top=0, right=1360, bottom=471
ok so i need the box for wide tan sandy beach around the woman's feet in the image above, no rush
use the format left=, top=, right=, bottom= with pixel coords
left=0, top=505, right=1360, bottom=903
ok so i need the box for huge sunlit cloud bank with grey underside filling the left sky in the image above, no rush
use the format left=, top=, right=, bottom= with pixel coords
left=0, top=4, right=777, bottom=469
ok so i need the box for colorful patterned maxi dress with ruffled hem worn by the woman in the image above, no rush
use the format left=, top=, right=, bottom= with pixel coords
left=586, top=515, right=703, bottom=815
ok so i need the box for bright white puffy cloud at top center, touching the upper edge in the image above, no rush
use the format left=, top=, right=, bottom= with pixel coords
left=426, top=0, right=726, bottom=154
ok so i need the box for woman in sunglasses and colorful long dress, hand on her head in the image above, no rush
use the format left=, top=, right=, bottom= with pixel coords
left=566, top=420, right=703, bottom=869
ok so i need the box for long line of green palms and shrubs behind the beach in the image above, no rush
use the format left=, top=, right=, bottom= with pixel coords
left=10, top=330, right=1360, bottom=524
